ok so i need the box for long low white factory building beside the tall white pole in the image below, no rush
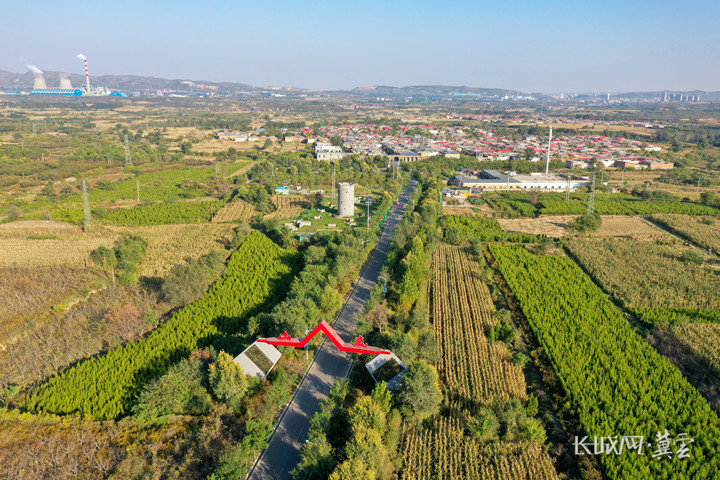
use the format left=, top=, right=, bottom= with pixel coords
left=452, top=170, right=590, bottom=192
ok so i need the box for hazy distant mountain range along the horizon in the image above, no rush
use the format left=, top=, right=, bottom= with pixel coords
left=0, top=70, right=720, bottom=102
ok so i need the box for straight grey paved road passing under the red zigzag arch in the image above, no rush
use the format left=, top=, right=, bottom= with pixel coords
left=248, top=181, right=417, bottom=480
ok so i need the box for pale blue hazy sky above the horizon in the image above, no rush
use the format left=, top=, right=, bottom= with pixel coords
left=0, top=0, right=720, bottom=92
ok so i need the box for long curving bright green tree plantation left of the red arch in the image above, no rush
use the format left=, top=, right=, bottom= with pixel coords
left=27, top=232, right=296, bottom=419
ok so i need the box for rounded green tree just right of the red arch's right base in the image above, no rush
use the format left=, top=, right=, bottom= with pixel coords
left=398, top=360, right=442, bottom=419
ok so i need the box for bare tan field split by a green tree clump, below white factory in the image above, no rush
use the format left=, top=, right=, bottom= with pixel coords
left=497, top=215, right=675, bottom=240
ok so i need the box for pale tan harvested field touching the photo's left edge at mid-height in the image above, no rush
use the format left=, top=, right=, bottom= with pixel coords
left=0, top=220, right=117, bottom=267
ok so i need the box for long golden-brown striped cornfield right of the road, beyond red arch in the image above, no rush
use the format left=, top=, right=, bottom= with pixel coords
left=430, top=245, right=526, bottom=408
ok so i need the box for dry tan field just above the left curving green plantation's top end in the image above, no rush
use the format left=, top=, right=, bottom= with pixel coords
left=108, top=223, right=234, bottom=277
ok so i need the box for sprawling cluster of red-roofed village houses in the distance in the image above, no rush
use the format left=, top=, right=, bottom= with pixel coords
left=218, top=116, right=674, bottom=169
